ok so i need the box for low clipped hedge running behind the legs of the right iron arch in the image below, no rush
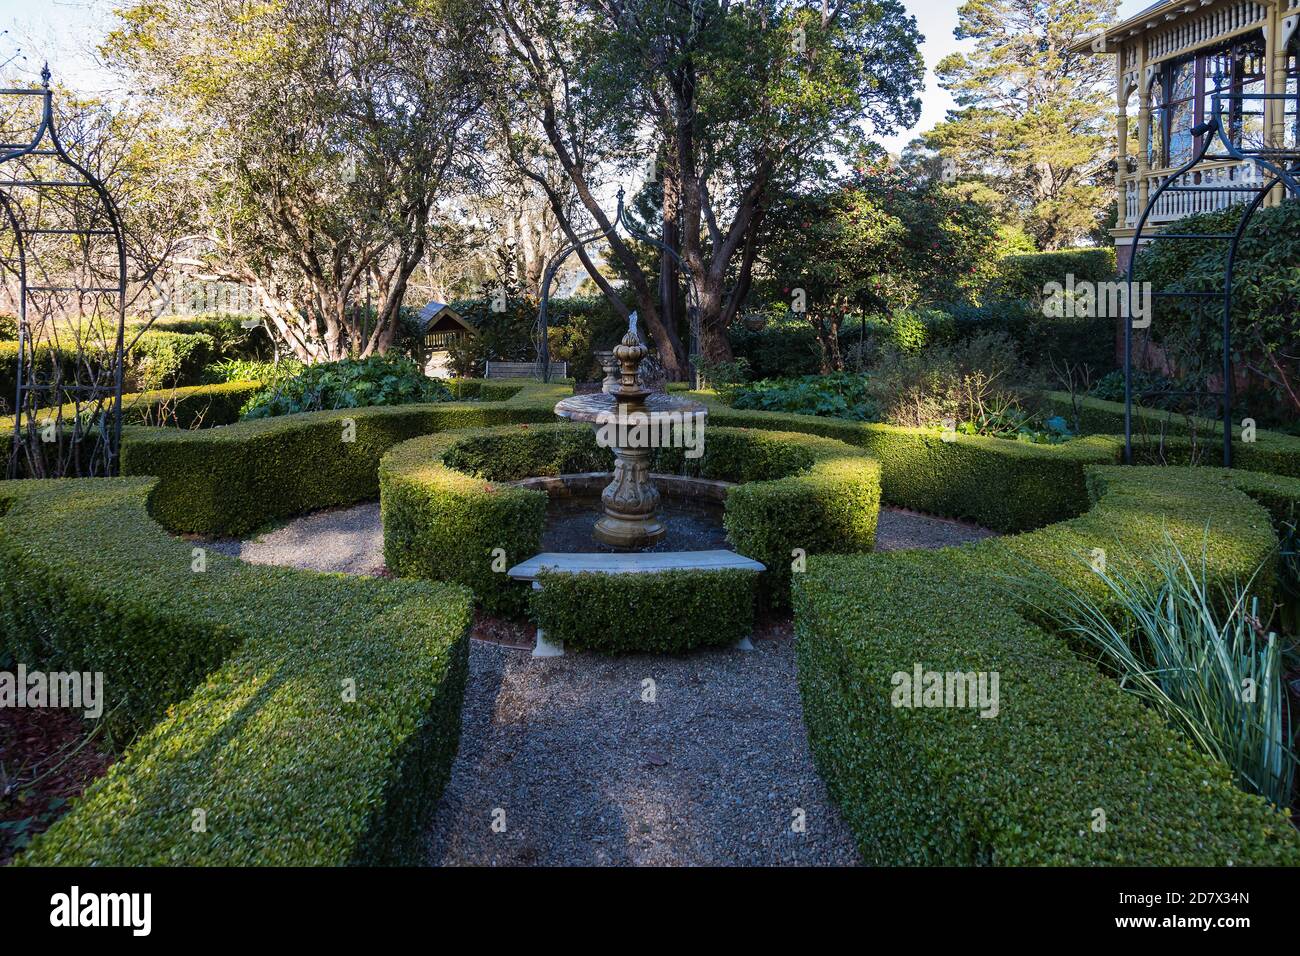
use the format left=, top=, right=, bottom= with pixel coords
left=1044, top=392, right=1300, bottom=477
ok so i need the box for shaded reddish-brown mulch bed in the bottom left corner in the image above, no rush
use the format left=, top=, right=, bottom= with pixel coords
left=0, top=708, right=113, bottom=866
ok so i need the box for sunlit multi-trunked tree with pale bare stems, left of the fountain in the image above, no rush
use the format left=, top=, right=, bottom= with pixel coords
left=104, top=0, right=481, bottom=362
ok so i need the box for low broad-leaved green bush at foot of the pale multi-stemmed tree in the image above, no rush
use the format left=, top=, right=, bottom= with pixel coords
left=244, top=355, right=451, bottom=419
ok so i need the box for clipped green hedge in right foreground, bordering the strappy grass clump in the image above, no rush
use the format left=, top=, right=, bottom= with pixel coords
left=794, top=467, right=1300, bottom=866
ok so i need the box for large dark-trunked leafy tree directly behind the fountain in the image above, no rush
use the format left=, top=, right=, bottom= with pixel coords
left=485, top=0, right=923, bottom=377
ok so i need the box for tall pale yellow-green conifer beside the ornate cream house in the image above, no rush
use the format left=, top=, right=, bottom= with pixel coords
left=926, top=0, right=1118, bottom=250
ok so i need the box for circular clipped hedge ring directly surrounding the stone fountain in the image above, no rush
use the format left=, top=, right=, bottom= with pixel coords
left=380, top=424, right=880, bottom=613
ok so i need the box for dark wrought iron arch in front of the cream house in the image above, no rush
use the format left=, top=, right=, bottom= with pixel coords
left=1125, top=74, right=1300, bottom=468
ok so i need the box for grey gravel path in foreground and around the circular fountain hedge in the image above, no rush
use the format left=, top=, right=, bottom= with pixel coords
left=197, top=503, right=991, bottom=866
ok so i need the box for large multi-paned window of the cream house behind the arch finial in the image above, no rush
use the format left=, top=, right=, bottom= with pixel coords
left=1147, top=34, right=1268, bottom=169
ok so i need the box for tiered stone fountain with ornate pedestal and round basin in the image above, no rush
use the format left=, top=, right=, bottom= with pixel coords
left=555, top=312, right=709, bottom=551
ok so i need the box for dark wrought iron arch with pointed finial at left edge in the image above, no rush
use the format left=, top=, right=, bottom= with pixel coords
left=0, top=65, right=126, bottom=477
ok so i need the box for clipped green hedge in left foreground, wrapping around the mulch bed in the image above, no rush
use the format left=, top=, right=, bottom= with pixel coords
left=0, top=479, right=471, bottom=866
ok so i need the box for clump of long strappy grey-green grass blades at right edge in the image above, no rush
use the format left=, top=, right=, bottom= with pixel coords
left=1040, top=532, right=1296, bottom=808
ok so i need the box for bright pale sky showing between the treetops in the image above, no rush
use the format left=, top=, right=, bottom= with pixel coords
left=0, top=0, right=1149, bottom=152
